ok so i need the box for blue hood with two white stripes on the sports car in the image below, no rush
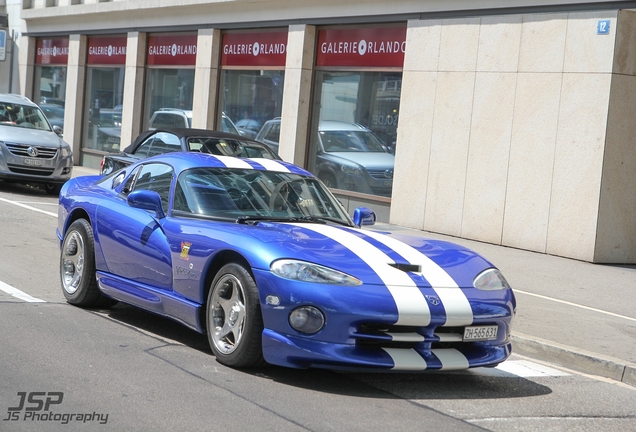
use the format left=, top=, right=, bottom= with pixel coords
left=246, top=223, right=493, bottom=288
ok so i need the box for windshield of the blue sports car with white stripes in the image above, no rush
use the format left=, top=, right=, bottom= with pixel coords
left=173, top=168, right=352, bottom=226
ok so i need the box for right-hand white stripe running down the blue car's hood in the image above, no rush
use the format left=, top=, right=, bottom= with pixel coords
left=364, top=230, right=473, bottom=326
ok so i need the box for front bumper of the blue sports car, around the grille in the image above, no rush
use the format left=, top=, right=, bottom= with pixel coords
left=255, top=271, right=516, bottom=371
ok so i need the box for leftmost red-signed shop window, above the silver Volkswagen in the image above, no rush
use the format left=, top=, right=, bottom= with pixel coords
left=33, top=38, right=68, bottom=129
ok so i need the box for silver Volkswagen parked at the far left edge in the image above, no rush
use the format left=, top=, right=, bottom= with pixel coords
left=0, top=94, right=73, bottom=195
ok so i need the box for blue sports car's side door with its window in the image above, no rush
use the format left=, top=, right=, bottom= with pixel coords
left=96, top=163, right=174, bottom=290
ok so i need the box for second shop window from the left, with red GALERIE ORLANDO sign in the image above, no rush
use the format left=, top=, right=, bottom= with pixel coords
left=81, top=36, right=126, bottom=167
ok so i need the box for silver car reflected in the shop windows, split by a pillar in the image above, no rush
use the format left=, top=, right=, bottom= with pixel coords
left=256, top=118, right=395, bottom=196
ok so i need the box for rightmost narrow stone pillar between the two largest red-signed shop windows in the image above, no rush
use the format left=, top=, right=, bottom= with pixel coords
left=278, top=24, right=316, bottom=166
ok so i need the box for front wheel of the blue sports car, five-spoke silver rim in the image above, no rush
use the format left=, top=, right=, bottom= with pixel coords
left=206, top=263, right=265, bottom=368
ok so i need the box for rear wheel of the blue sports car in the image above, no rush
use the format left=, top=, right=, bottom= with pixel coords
left=60, top=219, right=115, bottom=307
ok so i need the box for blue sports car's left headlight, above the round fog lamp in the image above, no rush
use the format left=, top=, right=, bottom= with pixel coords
left=270, top=259, right=362, bottom=286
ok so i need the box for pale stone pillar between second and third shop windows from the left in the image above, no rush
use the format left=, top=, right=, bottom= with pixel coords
left=120, top=32, right=147, bottom=150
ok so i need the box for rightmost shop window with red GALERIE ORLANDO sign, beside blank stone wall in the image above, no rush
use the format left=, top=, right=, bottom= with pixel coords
left=308, top=27, right=406, bottom=197
